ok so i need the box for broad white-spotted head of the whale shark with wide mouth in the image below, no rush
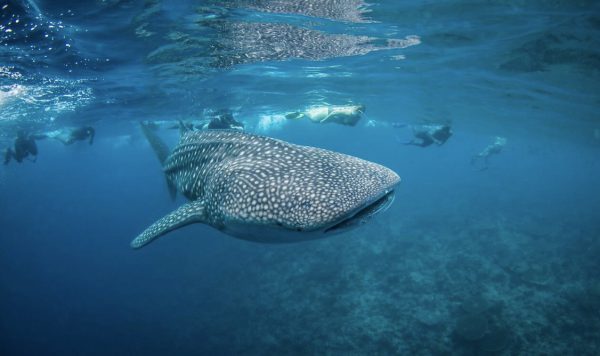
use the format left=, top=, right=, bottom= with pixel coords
left=206, top=140, right=400, bottom=242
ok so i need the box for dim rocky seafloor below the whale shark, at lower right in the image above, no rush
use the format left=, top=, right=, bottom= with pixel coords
left=171, top=209, right=600, bottom=355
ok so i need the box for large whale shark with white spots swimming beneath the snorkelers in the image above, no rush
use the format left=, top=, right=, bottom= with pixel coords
left=131, top=123, right=400, bottom=249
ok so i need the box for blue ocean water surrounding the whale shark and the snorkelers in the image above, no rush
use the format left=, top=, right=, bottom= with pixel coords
left=0, top=0, right=600, bottom=355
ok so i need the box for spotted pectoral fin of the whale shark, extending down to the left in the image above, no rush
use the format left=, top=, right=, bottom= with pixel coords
left=131, top=201, right=206, bottom=248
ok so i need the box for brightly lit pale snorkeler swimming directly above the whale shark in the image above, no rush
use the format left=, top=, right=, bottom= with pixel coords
left=285, top=105, right=365, bottom=126
